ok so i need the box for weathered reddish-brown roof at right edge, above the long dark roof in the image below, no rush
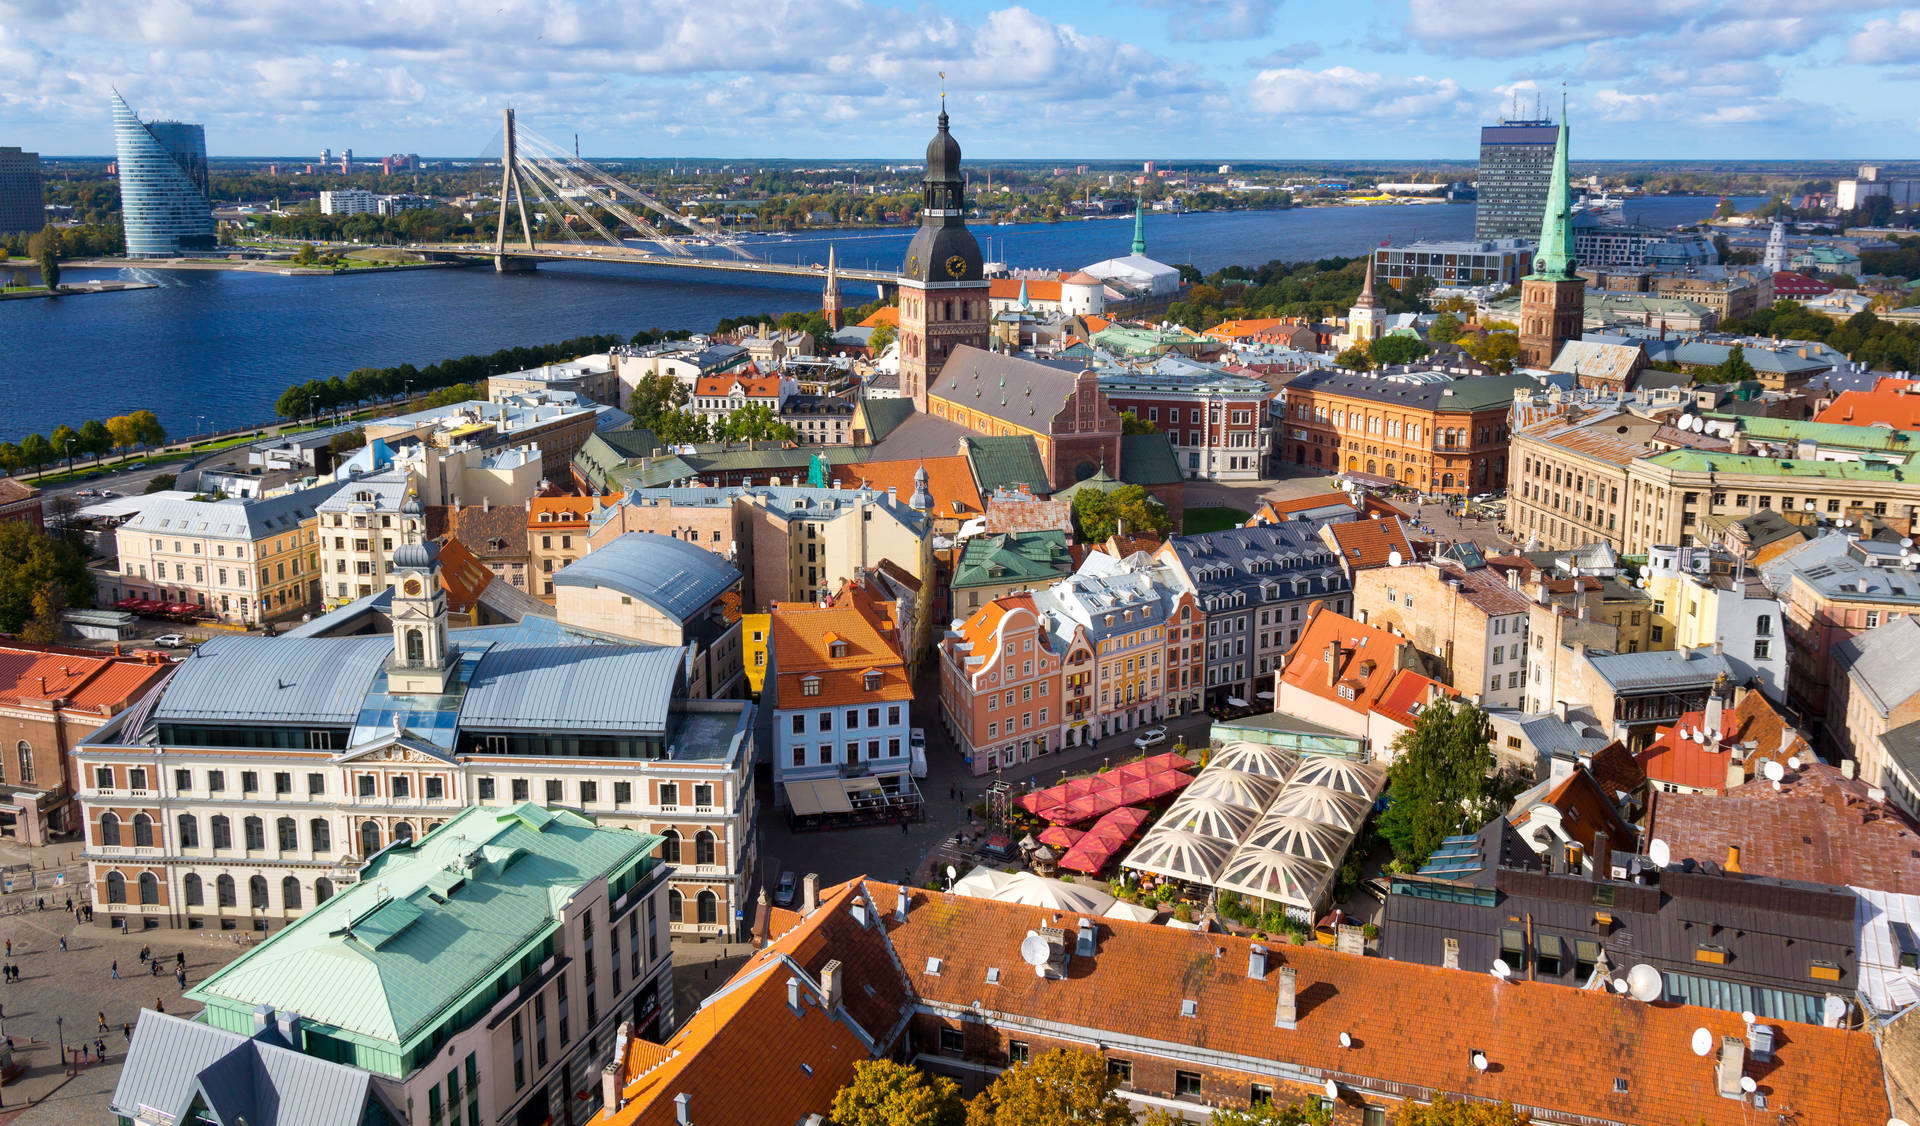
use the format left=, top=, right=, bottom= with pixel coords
left=1647, top=763, right=1920, bottom=892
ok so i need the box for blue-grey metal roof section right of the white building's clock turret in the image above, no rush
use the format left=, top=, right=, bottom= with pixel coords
left=458, top=638, right=682, bottom=734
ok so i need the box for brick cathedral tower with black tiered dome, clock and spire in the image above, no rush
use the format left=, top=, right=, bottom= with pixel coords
left=900, top=94, right=989, bottom=411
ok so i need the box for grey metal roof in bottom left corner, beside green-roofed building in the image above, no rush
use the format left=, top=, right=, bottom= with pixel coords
left=109, top=1011, right=374, bottom=1126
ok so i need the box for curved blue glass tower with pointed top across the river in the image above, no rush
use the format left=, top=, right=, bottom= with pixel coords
left=113, top=90, right=215, bottom=257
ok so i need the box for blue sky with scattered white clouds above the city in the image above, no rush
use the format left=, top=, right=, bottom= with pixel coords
left=0, top=0, right=1920, bottom=161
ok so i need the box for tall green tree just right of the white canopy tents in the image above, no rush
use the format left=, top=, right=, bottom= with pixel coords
left=1377, top=699, right=1509, bottom=870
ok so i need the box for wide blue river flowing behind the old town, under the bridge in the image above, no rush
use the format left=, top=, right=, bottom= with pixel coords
left=0, top=196, right=1761, bottom=442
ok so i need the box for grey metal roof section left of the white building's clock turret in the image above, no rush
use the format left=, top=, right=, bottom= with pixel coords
left=154, top=634, right=394, bottom=724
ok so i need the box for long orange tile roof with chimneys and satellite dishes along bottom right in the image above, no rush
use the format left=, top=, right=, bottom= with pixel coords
left=879, top=888, right=1887, bottom=1126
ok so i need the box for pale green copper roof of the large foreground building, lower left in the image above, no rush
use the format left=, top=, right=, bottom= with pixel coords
left=190, top=803, right=660, bottom=1055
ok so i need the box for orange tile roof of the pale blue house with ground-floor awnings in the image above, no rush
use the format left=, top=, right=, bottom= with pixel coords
left=768, top=598, right=914, bottom=707
